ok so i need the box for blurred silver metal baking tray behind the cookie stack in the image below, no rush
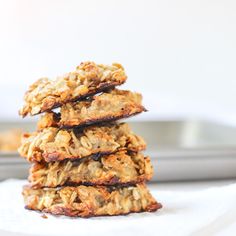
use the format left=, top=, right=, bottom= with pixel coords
left=0, top=120, right=236, bottom=181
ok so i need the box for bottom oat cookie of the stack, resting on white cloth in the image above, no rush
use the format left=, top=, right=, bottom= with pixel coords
left=23, top=184, right=162, bottom=217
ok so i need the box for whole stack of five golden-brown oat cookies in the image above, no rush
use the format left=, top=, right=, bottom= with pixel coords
left=19, top=62, right=161, bottom=217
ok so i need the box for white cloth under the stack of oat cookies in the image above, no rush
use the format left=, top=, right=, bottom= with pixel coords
left=0, top=180, right=236, bottom=236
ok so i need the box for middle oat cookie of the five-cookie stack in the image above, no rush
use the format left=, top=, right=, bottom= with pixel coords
left=19, top=123, right=146, bottom=162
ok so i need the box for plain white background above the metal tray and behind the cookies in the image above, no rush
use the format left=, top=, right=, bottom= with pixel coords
left=0, top=0, right=236, bottom=123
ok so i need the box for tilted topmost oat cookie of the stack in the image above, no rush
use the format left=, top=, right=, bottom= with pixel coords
left=19, top=62, right=127, bottom=117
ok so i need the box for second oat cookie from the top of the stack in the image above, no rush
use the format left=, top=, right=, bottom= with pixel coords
left=38, top=89, right=145, bottom=130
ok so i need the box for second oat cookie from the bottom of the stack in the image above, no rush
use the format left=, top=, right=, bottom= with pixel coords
left=29, top=151, right=153, bottom=188
